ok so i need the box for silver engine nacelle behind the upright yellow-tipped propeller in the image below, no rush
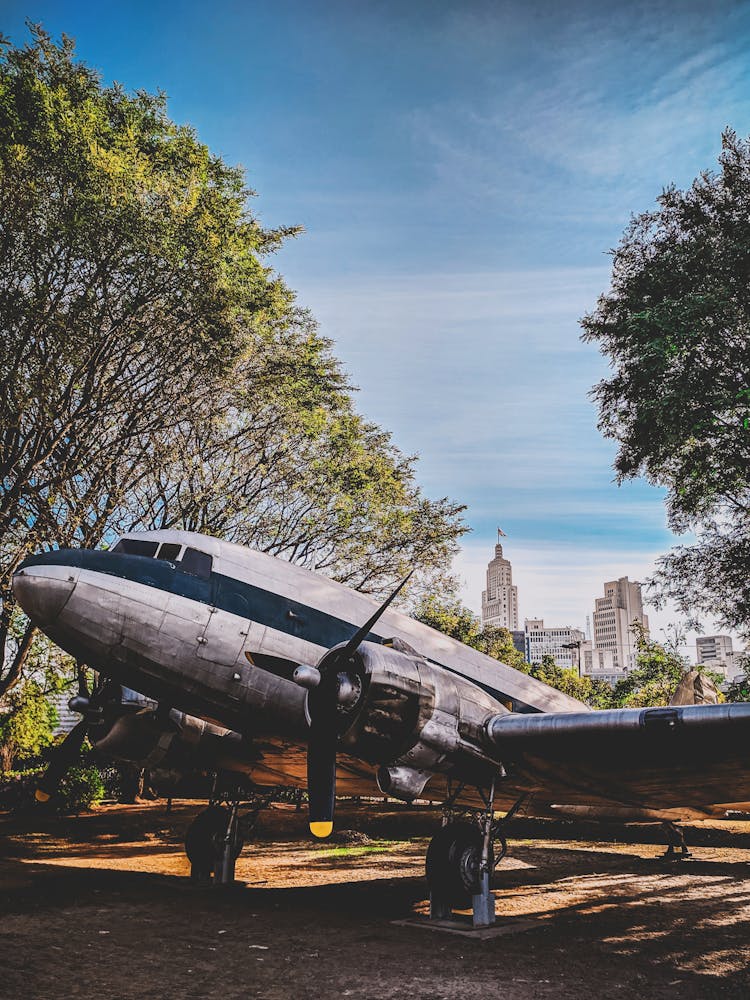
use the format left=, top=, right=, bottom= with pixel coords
left=329, top=639, right=507, bottom=801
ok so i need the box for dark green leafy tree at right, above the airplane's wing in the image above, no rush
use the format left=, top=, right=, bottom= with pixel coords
left=581, top=131, right=750, bottom=635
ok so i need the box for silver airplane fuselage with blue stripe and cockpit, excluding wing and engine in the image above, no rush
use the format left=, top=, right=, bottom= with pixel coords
left=13, top=531, right=586, bottom=780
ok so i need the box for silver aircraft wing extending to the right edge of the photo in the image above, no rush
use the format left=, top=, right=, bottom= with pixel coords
left=488, top=704, right=750, bottom=818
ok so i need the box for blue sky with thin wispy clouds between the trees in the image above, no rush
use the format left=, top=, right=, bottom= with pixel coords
left=0, top=0, right=750, bottom=652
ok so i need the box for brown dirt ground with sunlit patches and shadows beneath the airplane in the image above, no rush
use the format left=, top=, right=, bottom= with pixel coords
left=0, top=802, right=750, bottom=1000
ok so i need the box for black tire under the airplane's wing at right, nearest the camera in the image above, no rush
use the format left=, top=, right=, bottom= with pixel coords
left=425, top=822, right=493, bottom=909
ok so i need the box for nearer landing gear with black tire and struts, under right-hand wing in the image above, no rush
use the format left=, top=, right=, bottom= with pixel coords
left=426, top=781, right=506, bottom=927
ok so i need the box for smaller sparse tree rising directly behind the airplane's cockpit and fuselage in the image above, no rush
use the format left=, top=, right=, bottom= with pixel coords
left=122, top=308, right=465, bottom=594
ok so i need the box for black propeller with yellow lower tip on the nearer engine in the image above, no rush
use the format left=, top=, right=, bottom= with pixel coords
left=302, top=570, right=414, bottom=840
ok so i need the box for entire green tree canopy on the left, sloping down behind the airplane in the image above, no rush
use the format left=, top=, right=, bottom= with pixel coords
left=0, top=27, right=465, bottom=696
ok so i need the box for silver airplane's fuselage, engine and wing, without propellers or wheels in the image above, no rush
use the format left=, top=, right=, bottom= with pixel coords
left=13, top=531, right=750, bottom=815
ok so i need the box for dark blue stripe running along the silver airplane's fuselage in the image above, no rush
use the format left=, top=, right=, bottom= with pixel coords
left=19, top=549, right=538, bottom=713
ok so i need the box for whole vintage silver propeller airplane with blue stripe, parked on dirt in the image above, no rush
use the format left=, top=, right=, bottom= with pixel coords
left=12, top=530, right=750, bottom=926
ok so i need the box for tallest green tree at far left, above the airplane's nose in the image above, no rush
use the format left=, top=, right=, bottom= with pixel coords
left=0, top=27, right=300, bottom=693
